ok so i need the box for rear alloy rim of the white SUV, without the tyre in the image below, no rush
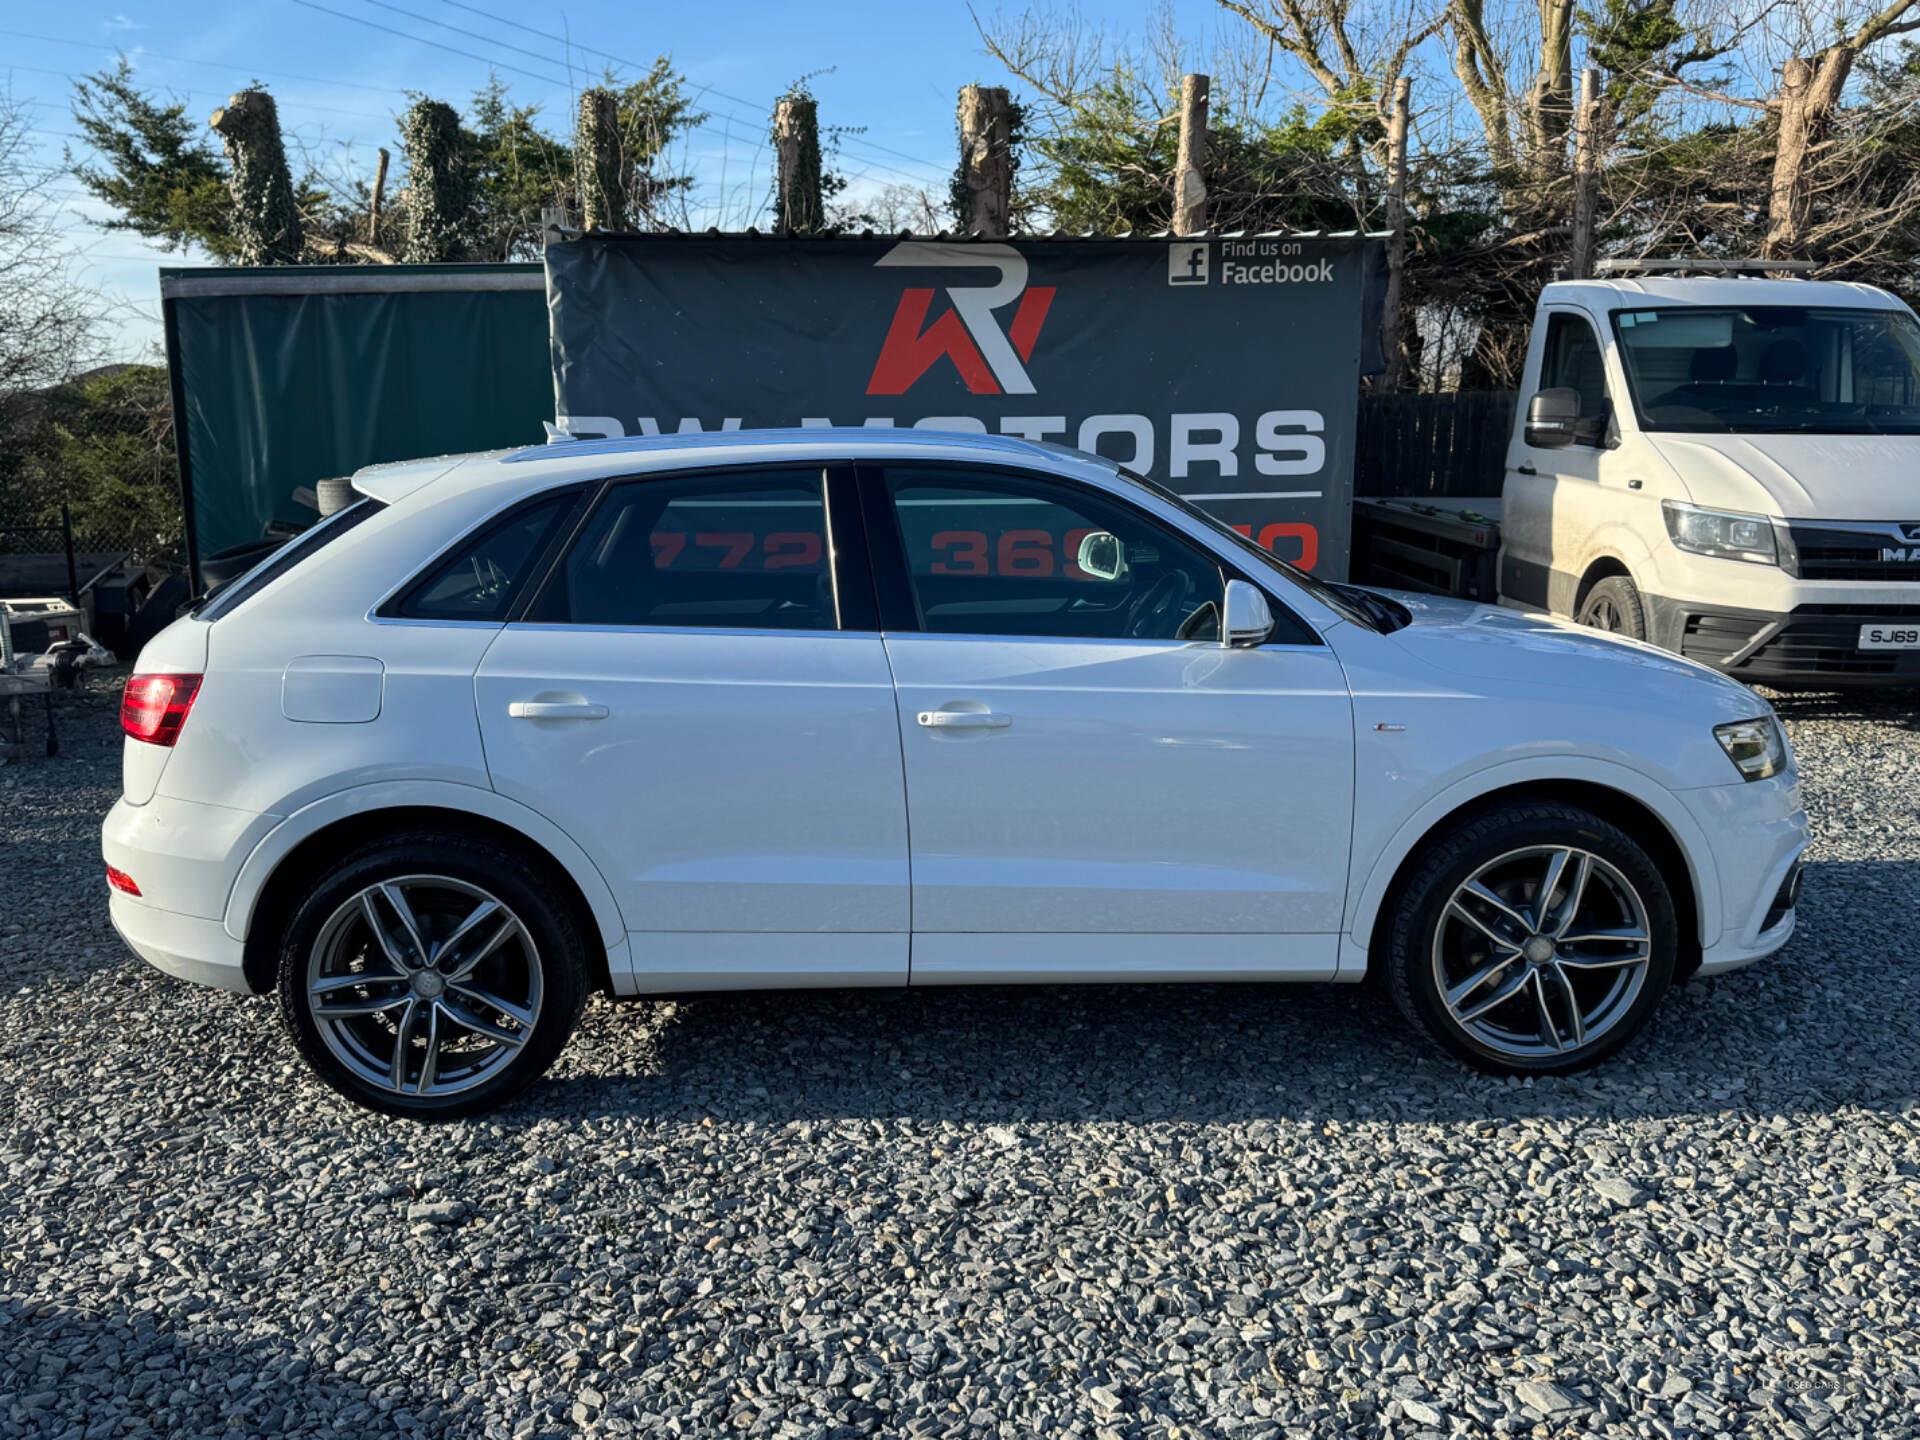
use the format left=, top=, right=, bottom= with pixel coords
left=305, top=876, right=545, bottom=1096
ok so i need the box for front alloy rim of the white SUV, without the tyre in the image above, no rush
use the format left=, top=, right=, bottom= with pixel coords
left=1432, top=845, right=1653, bottom=1060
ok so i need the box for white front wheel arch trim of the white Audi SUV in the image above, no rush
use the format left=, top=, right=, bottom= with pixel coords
left=1340, top=755, right=1720, bottom=979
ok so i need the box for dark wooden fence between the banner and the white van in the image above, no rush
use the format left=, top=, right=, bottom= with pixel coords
left=1354, top=390, right=1517, bottom=497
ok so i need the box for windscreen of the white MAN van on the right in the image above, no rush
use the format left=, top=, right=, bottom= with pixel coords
left=1613, top=305, right=1920, bottom=436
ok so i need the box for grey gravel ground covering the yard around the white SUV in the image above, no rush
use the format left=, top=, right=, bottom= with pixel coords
left=0, top=678, right=1920, bottom=1440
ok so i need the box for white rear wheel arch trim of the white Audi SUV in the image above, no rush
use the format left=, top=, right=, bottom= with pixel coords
left=223, top=780, right=626, bottom=960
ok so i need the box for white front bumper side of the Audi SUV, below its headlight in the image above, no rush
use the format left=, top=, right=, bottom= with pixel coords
left=1680, top=770, right=1809, bottom=975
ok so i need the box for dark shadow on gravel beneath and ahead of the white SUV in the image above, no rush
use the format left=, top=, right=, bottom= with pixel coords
left=526, top=862, right=1920, bottom=1127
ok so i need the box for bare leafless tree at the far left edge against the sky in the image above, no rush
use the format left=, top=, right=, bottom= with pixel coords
left=0, top=94, right=98, bottom=401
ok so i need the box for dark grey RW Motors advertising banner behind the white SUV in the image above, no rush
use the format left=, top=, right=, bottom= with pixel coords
left=547, top=234, right=1382, bottom=578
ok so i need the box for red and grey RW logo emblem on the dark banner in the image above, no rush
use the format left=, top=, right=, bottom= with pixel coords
left=866, top=240, right=1054, bottom=396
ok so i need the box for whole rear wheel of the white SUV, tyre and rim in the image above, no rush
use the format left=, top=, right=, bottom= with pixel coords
left=278, top=831, right=588, bottom=1119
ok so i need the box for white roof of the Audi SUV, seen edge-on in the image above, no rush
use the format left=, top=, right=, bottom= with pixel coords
left=353, top=426, right=1117, bottom=503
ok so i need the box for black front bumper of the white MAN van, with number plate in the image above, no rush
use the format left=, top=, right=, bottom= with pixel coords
left=1644, top=595, right=1920, bottom=685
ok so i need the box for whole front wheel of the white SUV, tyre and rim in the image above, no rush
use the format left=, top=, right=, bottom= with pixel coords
left=1380, top=801, right=1678, bottom=1075
